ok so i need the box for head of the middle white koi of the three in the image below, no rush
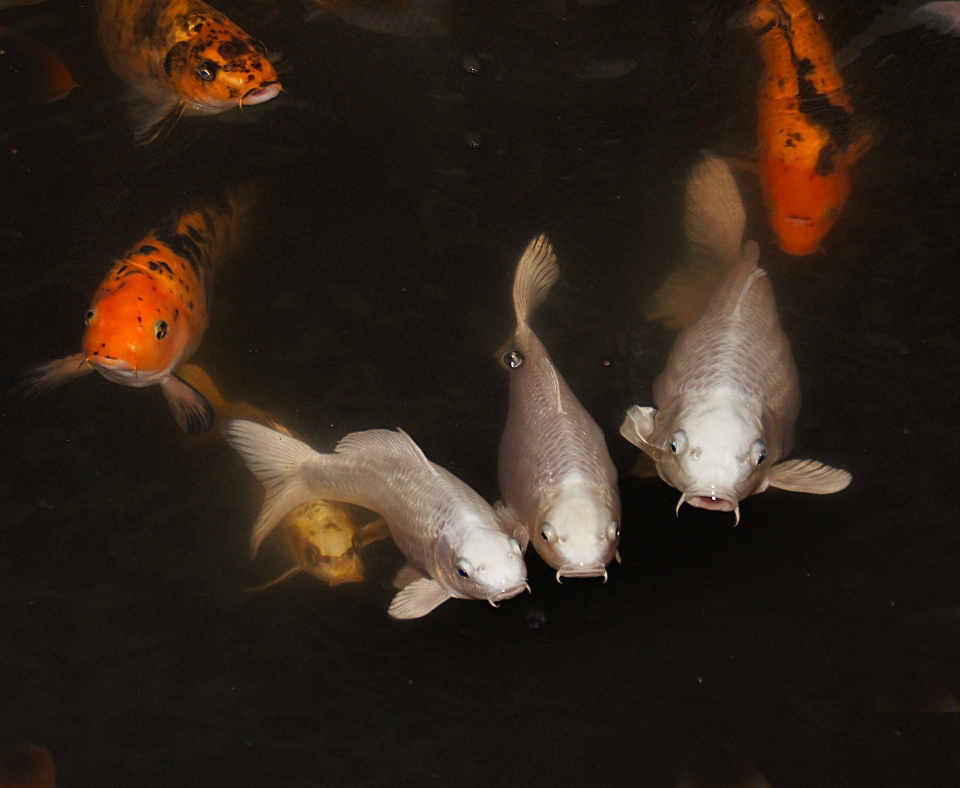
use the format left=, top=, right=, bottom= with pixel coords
left=531, top=483, right=620, bottom=580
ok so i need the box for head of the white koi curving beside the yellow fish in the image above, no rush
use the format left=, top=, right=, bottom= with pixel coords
left=439, top=527, right=529, bottom=605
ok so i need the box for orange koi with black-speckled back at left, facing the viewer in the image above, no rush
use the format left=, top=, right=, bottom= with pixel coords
left=11, top=198, right=249, bottom=433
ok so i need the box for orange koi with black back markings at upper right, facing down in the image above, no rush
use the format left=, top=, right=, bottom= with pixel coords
left=743, top=0, right=863, bottom=256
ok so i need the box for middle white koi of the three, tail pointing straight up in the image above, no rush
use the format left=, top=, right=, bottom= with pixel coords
left=498, top=235, right=620, bottom=580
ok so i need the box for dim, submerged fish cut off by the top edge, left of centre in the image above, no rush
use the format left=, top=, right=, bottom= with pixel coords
left=307, top=0, right=447, bottom=38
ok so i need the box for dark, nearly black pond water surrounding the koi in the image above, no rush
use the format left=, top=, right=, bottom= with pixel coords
left=0, top=0, right=960, bottom=788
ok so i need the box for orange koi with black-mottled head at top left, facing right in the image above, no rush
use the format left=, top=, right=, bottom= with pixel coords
left=98, top=0, right=282, bottom=145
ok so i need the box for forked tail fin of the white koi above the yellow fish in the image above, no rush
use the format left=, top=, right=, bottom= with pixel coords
left=220, top=419, right=320, bottom=557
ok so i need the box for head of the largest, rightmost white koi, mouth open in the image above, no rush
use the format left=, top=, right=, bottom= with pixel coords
left=657, top=397, right=775, bottom=520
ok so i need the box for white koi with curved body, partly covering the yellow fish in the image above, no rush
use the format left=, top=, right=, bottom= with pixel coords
left=222, top=420, right=527, bottom=619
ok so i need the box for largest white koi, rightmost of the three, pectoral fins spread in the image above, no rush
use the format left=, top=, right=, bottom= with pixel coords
left=620, top=156, right=851, bottom=522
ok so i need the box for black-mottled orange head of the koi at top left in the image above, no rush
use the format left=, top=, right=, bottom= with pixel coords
left=163, top=15, right=283, bottom=112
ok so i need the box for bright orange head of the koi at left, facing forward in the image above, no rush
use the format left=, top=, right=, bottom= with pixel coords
left=83, top=271, right=190, bottom=375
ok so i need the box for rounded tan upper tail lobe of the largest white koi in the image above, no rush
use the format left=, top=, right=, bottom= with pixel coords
left=685, top=153, right=747, bottom=265
